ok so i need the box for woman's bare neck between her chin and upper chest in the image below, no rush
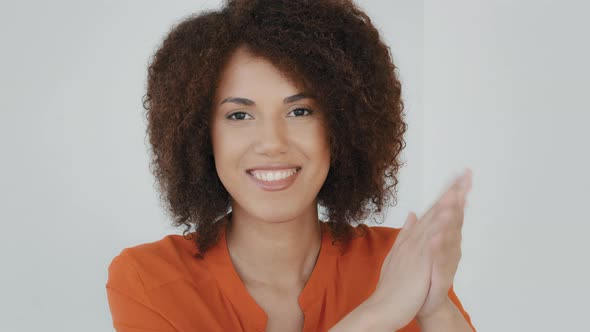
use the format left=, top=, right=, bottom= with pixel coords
left=226, top=208, right=322, bottom=288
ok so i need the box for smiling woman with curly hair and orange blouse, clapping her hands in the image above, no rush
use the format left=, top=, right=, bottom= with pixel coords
left=106, top=0, right=472, bottom=332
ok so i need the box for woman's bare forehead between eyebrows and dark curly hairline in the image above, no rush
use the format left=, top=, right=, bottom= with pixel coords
left=216, top=47, right=302, bottom=100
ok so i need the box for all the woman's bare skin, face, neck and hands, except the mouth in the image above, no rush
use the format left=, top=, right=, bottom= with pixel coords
left=211, top=47, right=471, bottom=331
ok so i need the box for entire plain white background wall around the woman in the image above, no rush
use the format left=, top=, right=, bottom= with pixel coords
left=0, top=0, right=590, bottom=332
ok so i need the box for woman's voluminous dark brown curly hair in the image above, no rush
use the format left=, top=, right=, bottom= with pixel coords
left=143, top=0, right=407, bottom=258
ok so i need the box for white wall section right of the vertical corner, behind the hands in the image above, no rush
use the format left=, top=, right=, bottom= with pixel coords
left=423, top=0, right=590, bottom=331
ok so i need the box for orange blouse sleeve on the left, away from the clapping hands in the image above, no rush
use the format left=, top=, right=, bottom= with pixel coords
left=106, top=249, right=177, bottom=332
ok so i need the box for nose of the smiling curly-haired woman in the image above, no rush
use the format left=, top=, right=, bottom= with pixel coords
left=254, top=118, right=289, bottom=156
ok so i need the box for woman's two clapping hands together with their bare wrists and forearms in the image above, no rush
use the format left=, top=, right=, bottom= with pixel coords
left=330, top=169, right=472, bottom=332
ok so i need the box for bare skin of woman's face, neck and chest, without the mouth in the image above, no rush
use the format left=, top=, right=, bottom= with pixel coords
left=211, top=47, right=330, bottom=331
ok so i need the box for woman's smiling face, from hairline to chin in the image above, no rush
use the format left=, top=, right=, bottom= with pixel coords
left=211, top=48, right=330, bottom=222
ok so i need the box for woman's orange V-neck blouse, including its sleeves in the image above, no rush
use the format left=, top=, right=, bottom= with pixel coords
left=106, top=218, right=475, bottom=332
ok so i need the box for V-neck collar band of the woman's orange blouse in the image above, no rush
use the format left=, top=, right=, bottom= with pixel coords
left=204, top=215, right=338, bottom=332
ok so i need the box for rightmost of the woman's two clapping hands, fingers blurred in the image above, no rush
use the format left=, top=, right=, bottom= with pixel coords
left=416, top=169, right=472, bottom=320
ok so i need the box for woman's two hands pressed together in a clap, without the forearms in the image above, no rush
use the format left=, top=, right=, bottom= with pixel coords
left=369, top=170, right=471, bottom=328
